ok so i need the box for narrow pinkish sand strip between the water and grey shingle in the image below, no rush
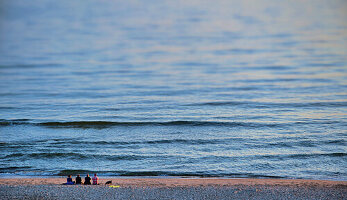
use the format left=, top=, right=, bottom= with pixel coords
left=0, top=176, right=347, bottom=188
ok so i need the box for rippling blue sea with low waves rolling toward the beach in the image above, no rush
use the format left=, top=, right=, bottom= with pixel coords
left=0, top=0, right=347, bottom=180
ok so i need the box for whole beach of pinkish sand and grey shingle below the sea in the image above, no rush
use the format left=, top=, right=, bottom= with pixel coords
left=0, top=177, right=347, bottom=199
